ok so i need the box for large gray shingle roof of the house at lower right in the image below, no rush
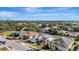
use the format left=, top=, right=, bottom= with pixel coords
left=55, top=37, right=74, bottom=48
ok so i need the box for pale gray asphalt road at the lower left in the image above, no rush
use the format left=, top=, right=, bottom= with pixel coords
left=0, top=36, right=32, bottom=51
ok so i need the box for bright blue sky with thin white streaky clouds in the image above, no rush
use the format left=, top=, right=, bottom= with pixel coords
left=0, top=7, right=79, bottom=21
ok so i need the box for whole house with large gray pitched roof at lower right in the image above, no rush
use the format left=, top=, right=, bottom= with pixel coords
left=54, top=37, right=74, bottom=51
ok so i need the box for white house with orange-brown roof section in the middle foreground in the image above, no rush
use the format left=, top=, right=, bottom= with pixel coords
left=25, top=31, right=53, bottom=42
